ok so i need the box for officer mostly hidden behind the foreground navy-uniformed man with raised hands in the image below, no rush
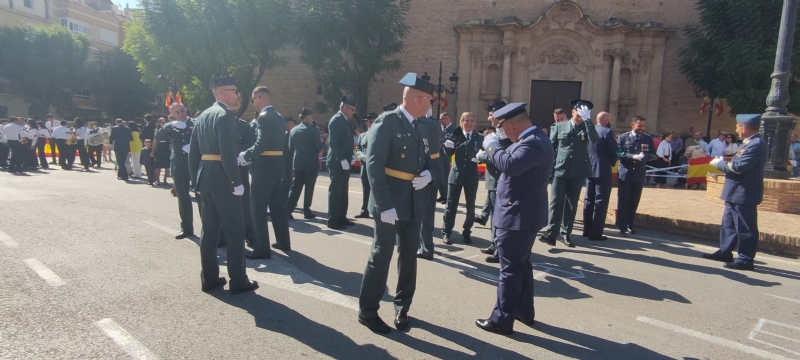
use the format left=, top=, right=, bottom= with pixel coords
left=475, top=100, right=508, bottom=263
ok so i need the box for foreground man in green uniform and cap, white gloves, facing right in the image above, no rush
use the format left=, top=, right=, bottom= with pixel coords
left=358, top=73, right=440, bottom=334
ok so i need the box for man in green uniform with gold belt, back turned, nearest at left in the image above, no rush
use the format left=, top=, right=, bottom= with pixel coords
left=189, top=77, right=258, bottom=294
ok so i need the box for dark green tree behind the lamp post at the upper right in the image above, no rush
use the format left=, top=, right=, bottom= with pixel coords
left=679, top=0, right=800, bottom=114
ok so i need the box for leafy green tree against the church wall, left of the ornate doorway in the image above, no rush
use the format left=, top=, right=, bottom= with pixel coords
left=296, top=0, right=410, bottom=125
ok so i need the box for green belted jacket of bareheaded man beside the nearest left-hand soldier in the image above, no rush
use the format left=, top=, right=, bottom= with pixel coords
left=244, top=106, right=286, bottom=179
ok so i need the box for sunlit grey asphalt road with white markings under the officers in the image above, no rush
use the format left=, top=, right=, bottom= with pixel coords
left=0, top=169, right=800, bottom=359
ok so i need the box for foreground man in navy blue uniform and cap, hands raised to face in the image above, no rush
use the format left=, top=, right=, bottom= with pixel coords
left=475, top=103, right=554, bottom=334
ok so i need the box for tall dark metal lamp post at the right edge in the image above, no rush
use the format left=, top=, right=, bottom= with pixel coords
left=760, top=0, right=797, bottom=179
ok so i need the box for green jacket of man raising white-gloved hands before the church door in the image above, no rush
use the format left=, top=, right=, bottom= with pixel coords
left=550, top=120, right=597, bottom=179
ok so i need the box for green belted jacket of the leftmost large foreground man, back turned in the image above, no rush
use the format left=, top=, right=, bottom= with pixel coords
left=189, top=102, right=242, bottom=193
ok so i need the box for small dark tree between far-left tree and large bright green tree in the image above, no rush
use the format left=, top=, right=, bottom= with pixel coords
left=90, top=48, right=155, bottom=119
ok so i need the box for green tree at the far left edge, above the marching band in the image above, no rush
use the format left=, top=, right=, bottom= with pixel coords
left=0, top=26, right=89, bottom=119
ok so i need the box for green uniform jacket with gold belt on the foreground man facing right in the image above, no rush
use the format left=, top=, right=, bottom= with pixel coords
left=367, top=107, right=439, bottom=221
